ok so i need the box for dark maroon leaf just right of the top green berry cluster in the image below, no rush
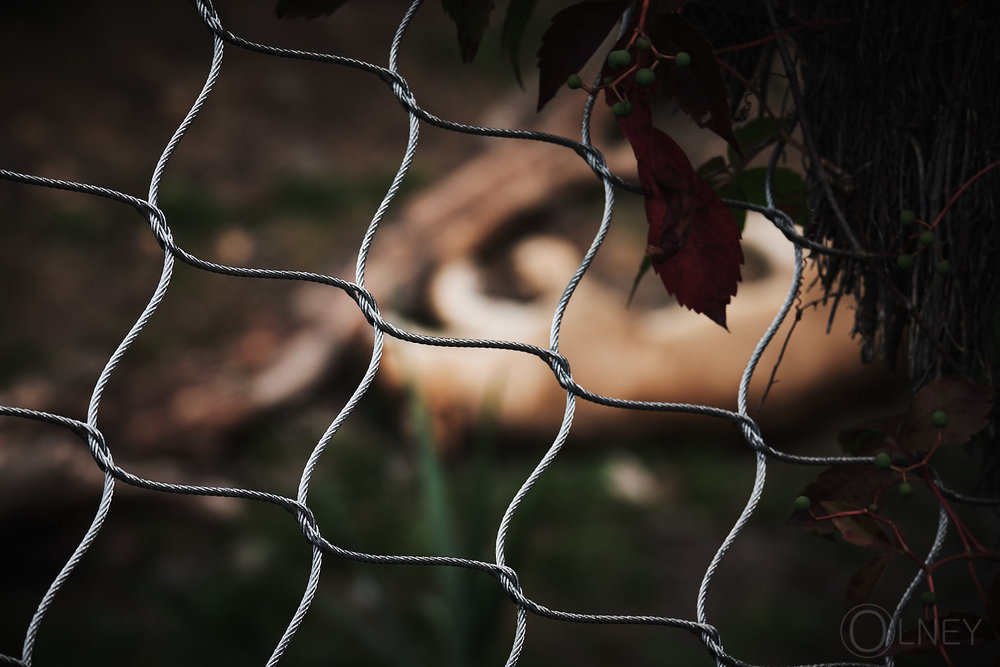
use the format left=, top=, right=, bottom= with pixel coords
left=646, top=12, right=743, bottom=156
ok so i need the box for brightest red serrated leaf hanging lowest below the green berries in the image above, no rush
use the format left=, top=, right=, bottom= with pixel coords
left=602, top=61, right=743, bottom=328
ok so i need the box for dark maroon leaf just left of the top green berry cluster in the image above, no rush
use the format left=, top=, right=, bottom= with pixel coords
left=538, top=0, right=629, bottom=111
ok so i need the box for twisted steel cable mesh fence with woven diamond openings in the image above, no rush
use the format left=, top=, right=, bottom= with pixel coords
left=0, top=0, right=988, bottom=665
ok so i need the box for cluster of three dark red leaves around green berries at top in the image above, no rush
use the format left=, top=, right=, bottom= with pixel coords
left=538, top=0, right=743, bottom=327
